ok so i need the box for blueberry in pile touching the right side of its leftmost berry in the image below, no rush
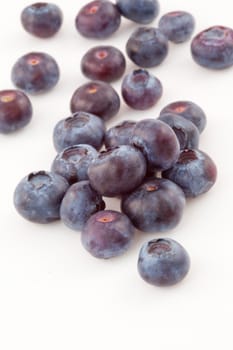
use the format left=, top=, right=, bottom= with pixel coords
left=60, top=181, right=105, bottom=231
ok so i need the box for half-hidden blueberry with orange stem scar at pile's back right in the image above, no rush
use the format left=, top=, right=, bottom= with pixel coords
left=160, top=101, right=206, bottom=133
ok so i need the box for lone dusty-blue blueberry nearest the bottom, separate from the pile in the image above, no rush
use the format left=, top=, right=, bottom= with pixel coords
left=138, top=238, right=190, bottom=287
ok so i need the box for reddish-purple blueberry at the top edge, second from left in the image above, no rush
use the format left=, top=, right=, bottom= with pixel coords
left=75, top=0, right=121, bottom=39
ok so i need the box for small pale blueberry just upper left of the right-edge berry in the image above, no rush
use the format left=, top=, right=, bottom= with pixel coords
left=159, top=11, right=195, bottom=44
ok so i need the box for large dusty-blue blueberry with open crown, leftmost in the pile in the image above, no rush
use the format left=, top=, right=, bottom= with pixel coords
left=14, top=171, right=69, bottom=224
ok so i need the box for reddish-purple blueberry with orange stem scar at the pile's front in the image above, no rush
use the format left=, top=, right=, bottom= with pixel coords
left=81, top=210, right=135, bottom=259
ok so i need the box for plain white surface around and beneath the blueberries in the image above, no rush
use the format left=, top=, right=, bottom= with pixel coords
left=0, top=0, right=230, bottom=350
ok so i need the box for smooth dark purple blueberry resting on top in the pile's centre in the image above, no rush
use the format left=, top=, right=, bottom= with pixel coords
left=88, top=145, right=146, bottom=197
